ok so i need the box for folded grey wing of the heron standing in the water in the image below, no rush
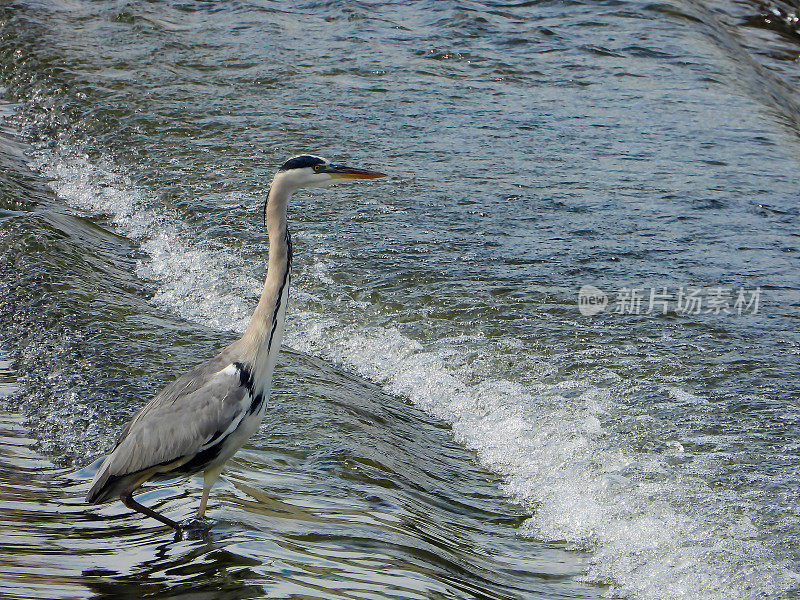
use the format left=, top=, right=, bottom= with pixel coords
left=87, top=361, right=251, bottom=502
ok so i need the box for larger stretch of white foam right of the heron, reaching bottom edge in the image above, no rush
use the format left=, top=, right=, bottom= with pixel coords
left=284, top=324, right=800, bottom=599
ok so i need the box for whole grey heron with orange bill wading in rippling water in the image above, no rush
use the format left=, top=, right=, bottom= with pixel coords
left=86, top=154, right=384, bottom=531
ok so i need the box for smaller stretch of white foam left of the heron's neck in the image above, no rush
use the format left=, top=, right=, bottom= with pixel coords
left=31, top=149, right=261, bottom=331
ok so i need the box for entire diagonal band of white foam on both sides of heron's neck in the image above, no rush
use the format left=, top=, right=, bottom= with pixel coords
left=29, top=150, right=800, bottom=599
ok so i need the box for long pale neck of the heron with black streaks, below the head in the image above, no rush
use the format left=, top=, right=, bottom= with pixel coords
left=241, top=178, right=292, bottom=388
